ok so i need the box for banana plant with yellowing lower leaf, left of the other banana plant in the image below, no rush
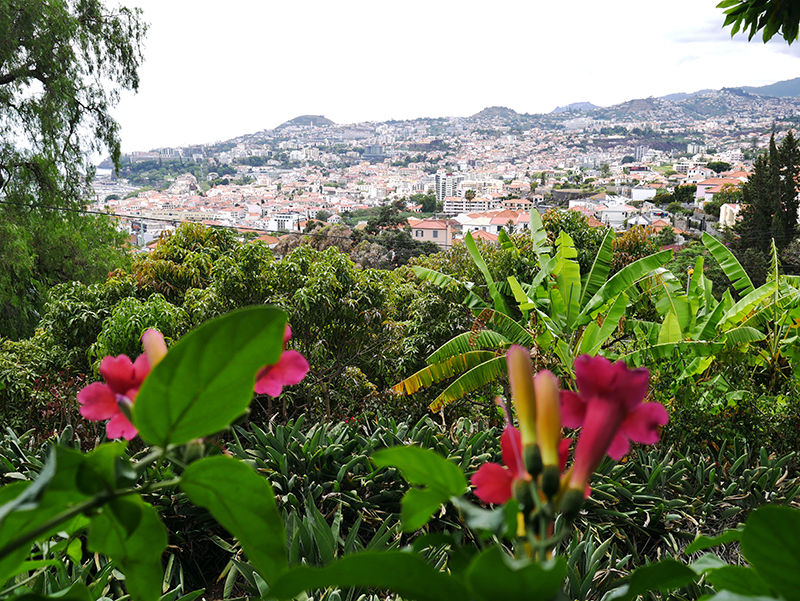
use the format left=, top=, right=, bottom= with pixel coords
left=394, top=209, right=672, bottom=411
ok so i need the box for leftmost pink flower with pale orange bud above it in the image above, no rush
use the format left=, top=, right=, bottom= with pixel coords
left=78, top=329, right=167, bottom=440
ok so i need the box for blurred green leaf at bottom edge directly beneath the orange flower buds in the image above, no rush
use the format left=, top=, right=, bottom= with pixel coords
left=464, top=546, right=567, bottom=601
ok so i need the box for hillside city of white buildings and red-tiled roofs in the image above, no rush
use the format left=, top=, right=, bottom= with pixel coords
left=92, top=89, right=800, bottom=249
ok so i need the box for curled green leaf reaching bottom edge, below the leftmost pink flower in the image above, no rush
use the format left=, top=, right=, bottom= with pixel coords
left=88, top=497, right=167, bottom=601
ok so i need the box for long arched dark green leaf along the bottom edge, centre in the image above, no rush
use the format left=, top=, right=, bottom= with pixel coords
left=269, top=551, right=469, bottom=601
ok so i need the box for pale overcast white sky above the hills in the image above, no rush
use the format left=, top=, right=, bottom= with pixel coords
left=113, top=0, right=800, bottom=152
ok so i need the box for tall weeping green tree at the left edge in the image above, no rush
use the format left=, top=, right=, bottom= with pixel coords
left=0, top=0, right=147, bottom=337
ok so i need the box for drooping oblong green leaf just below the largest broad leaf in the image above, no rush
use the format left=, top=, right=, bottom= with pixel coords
left=181, top=456, right=288, bottom=584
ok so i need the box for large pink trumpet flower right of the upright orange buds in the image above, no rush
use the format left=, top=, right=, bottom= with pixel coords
left=561, top=355, right=669, bottom=491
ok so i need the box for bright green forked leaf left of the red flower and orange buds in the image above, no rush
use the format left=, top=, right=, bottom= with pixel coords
left=372, top=446, right=467, bottom=532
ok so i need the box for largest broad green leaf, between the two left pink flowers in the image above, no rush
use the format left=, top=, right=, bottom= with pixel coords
left=133, top=306, right=286, bottom=447
